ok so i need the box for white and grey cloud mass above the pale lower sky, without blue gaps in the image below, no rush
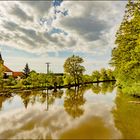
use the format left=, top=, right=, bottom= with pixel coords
left=0, top=1, right=124, bottom=53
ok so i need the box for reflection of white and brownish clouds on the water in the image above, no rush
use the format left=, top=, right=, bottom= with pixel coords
left=0, top=84, right=121, bottom=139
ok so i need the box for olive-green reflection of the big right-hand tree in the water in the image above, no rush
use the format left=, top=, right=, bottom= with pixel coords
left=112, top=92, right=140, bottom=139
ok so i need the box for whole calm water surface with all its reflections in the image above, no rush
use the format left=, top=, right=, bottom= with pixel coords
left=0, top=83, right=140, bottom=139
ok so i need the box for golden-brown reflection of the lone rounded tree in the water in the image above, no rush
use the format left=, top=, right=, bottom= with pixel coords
left=64, top=87, right=86, bottom=118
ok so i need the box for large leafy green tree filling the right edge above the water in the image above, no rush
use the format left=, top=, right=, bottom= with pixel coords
left=111, top=0, right=140, bottom=94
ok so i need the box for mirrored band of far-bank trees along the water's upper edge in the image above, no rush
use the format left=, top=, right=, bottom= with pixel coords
left=0, top=82, right=115, bottom=111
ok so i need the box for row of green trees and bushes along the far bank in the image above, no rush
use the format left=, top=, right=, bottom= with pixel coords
left=1, top=55, right=115, bottom=88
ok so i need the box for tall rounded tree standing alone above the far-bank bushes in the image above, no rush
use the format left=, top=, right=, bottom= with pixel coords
left=64, top=55, right=85, bottom=84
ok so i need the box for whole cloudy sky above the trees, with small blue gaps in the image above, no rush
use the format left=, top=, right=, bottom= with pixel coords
left=0, top=1, right=126, bottom=73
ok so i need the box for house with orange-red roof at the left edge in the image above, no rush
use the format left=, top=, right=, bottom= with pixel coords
left=0, top=53, right=24, bottom=78
